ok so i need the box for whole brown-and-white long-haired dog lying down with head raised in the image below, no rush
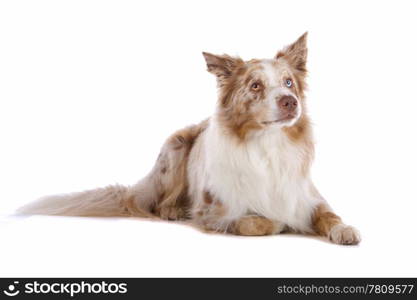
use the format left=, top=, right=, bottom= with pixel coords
left=20, top=33, right=360, bottom=244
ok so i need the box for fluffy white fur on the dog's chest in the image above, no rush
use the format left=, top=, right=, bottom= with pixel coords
left=204, top=122, right=318, bottom=231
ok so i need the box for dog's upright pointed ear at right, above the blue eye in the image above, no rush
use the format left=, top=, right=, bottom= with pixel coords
left=275, top=32, right=307, bottom=73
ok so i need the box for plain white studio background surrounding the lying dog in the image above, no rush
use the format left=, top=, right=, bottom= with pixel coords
left=0, top=0, right=417, bottom=277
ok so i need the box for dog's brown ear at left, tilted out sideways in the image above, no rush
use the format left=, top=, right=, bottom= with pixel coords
left=203, top=52, right=243, bottom=83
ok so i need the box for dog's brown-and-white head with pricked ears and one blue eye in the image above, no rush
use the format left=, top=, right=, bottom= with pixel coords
left=203, top=33, right=307, bottom=139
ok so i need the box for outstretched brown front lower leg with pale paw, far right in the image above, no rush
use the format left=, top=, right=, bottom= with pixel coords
left=312, top=203, right=361, bottom=245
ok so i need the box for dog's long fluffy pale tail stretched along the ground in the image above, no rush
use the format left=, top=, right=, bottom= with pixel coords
left=16, top=180, right=155, bottom=217
